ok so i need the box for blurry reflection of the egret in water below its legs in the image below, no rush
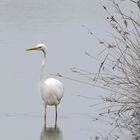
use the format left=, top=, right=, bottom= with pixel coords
left=40, top=126, right=63, bottom=140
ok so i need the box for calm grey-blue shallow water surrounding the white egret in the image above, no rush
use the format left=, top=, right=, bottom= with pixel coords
left=0, top=0, right=132, bottom=140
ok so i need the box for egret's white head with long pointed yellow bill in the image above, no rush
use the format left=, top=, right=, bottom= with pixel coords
left=26, top=43, right=47, bottom=52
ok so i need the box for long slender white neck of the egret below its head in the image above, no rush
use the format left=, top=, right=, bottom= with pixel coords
left=40, top=50, right=47, bottom=83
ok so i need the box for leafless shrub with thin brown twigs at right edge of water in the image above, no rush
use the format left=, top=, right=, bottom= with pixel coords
left=93, top=0, right=140, bottom=139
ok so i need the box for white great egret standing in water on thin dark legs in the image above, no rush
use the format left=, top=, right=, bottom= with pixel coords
left=26, top=43, right=64, bottom=127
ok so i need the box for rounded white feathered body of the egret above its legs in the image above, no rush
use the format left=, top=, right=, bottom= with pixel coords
left=41, top=78, right=64, bottom=105
